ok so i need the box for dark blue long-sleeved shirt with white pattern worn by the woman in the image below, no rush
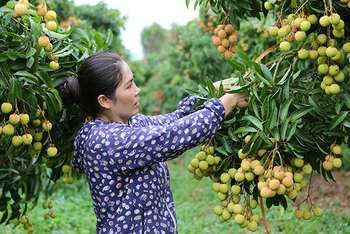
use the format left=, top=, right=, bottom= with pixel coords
left=73, top=96, right=225, bottom=234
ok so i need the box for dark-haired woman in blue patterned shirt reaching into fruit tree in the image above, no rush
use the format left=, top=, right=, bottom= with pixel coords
left=62, top=52, right=248, bottom=234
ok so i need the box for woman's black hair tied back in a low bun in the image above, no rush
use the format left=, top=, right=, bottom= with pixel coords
left=58, top=52, right=124, bottom=117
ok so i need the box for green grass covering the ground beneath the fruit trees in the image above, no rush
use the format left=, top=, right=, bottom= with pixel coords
left=0, top=149, right=350, bottom=234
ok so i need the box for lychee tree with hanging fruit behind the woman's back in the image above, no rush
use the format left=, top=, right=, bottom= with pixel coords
left=0, top=0, right=119, bottom=230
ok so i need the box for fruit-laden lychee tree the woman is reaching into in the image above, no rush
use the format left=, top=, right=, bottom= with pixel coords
left=186, top=0, right=350, bottom=233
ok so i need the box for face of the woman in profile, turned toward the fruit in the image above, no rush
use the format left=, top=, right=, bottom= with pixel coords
left=108, top=62, right=140, bottom=124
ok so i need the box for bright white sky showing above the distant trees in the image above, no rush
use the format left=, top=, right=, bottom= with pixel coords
left=74, top=0, right=199, bottom=60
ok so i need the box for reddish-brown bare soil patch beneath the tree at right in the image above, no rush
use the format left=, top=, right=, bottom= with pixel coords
left=296, top=171, right=350, bottom=213
